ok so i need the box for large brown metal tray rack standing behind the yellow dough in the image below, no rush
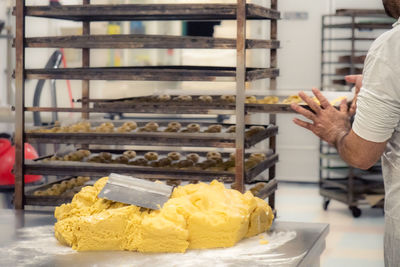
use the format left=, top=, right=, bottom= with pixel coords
left=14, top=0, right=289, bottom=209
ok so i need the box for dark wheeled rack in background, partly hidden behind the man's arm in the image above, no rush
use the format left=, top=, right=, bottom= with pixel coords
left=319, top=9, right=395, bottom=217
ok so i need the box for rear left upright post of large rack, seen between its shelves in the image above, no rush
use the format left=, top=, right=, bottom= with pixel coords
left=82, top=0, right=90, bottom=119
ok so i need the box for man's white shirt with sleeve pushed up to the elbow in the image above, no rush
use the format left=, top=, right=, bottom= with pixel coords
left=353, top=19, right=400, bottom=220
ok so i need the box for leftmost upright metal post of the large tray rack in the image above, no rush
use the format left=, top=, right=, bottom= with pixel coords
left=14, top=0, right=25, bottom=209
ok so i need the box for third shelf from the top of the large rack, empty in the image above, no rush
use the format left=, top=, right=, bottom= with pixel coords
left=25, top=66, right=279, bottom=81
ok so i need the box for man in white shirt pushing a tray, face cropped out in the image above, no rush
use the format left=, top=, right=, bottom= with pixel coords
left=292, top=0, right=400, bottom=266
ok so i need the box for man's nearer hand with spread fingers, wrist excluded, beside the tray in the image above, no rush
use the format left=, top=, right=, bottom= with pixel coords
left=291, top=88, right=351, bottom=147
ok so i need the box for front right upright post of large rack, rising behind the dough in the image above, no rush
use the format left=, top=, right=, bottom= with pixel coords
left=235, top=0, right=246, bottom=192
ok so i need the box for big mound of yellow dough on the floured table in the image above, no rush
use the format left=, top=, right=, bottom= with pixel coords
left=54, top=177, right=274, bottom=252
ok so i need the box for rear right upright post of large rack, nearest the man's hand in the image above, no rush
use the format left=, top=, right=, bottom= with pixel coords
left=268, top=0, right=278, bottom=210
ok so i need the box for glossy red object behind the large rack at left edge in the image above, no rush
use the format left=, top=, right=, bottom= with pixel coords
left=0, top=138, right=42, bottom=185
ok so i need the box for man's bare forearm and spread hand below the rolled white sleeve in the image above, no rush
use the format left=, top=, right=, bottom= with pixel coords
left=291, top=89, right=386, bottom=169
